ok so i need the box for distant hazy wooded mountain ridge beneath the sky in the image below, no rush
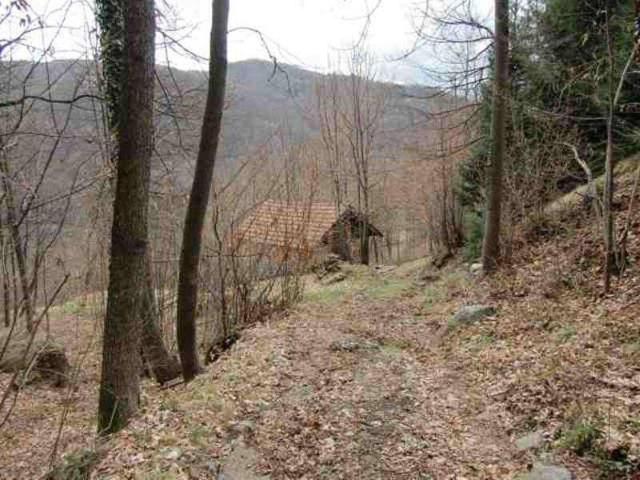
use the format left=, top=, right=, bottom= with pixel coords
left=0, top=60, right=458, bottom=202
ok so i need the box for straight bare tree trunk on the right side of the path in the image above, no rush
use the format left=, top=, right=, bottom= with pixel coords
left=482, top=0, right=509, bottom=273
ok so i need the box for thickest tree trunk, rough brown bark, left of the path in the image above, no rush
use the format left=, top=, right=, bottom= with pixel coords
left=98, top=0, right=155, bottom=434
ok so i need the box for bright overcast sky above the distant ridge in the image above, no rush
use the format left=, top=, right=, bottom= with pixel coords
left=5, top=0, right=492, bottom=82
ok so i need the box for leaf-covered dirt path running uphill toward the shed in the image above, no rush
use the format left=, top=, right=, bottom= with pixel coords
left=208, top=274, right=515, bottom=479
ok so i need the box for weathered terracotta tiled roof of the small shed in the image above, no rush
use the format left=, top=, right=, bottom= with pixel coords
left=238, top=200, right=338, bottom=249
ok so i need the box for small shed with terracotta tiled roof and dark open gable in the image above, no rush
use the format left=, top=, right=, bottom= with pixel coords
left=236, top=200, right=383, bottom=260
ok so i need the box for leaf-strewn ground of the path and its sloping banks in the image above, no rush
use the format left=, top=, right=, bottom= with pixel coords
left=0, top=159, right=640, bottom=480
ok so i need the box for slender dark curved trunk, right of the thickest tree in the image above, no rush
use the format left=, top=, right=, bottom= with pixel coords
left=177, top=0, right=229, bottom=382
